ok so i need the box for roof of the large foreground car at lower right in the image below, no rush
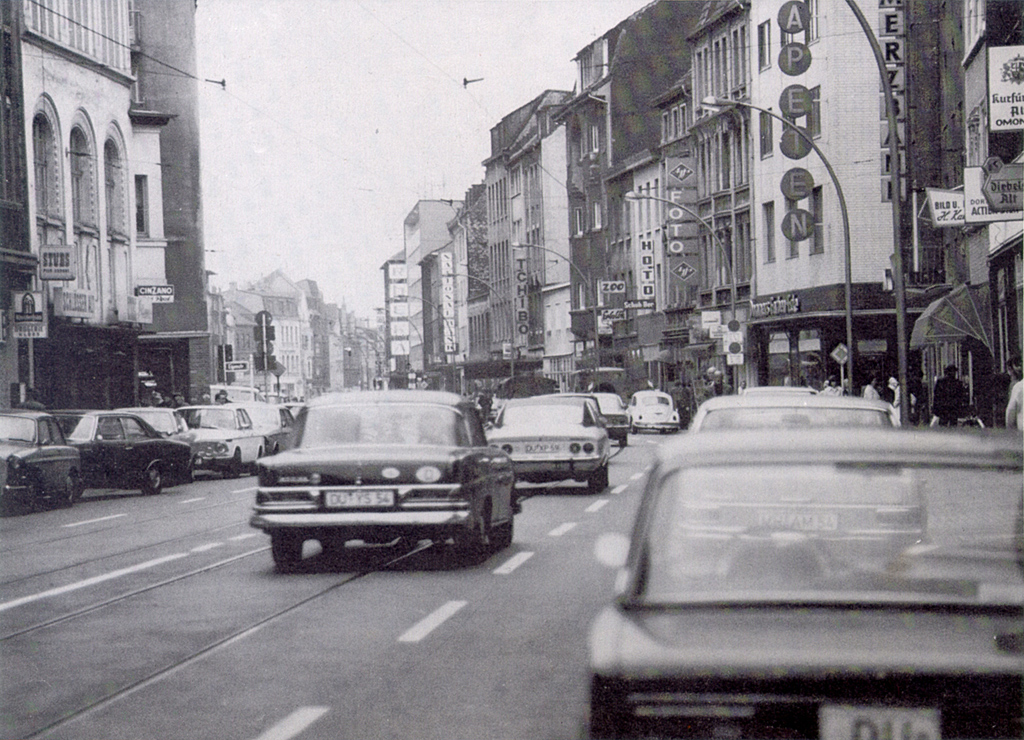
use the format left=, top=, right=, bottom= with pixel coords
left=657, top=428, right=1024, bottom=470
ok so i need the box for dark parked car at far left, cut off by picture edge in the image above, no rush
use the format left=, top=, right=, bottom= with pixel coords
left=0, top=410, right=82, bottom=514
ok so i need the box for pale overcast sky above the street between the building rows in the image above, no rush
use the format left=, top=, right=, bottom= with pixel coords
left=197, top=0, right=648, bottom=318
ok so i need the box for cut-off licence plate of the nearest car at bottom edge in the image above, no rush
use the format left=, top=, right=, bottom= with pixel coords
left=818, top=705, right=940, bottom=740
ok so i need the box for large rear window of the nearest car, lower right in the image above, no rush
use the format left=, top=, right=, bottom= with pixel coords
left=638, top=464, right=1024, bottom=605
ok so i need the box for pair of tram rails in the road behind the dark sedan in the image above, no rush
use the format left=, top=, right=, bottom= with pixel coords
left=18, top=542, right=435, bottom=740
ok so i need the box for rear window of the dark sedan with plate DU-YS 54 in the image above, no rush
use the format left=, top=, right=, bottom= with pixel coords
left=300, top=403, right=468, bottom=447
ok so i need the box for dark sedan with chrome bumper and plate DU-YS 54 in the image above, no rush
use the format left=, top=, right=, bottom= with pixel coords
left=250, top=390, right=518, bottom=571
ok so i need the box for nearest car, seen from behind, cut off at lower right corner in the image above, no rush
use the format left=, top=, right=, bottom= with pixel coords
left=589, top=429, right=1024, bottom=739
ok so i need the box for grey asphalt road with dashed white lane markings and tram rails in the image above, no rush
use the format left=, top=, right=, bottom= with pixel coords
left=0, top=435, right=669, bottom=740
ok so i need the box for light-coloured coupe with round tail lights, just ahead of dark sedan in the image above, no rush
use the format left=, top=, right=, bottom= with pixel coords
left=487, top=393, right=611, bottom=493
